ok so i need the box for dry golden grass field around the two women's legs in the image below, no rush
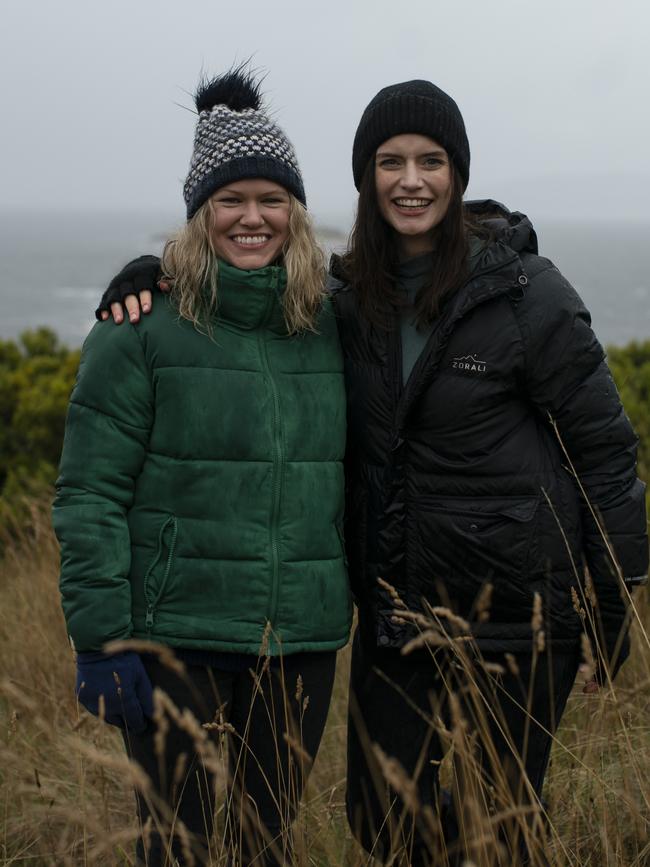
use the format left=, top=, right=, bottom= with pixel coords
left=0, top=504, right=650, bottom=867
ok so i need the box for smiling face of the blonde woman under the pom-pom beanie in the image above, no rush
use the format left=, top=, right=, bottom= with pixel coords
left=210, top=178, right=290, bottom=270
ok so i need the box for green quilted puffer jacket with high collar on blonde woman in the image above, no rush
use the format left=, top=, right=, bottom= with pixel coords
left=54, top=262, right=351, bottom=654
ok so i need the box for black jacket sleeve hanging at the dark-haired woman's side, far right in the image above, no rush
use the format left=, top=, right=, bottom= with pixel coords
left=518, top=260, right=648, bottom=676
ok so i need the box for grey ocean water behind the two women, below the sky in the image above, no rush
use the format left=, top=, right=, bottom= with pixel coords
left=0, top=213, right=650, bottom=346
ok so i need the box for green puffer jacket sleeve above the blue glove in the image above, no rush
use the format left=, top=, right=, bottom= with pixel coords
left=53, top=322, right=153, bottom=651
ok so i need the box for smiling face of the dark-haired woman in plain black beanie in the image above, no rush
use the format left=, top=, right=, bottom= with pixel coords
left=375, top=133, right=453, bottom=257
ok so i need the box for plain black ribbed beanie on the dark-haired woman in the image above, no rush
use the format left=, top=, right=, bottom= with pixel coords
left=352, top=80, right=469, bottom=190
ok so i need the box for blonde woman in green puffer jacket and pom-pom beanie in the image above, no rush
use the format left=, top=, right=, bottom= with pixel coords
left=54, top=68, right=351, bottom=865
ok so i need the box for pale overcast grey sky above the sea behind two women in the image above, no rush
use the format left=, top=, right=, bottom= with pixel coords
left=0, top=0, right=650, bottom=228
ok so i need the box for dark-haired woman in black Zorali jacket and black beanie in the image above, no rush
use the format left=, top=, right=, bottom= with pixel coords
left=93, top=81, right=648, bottom=865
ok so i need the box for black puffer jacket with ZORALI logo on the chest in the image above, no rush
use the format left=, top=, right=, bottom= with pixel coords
left=335, top=202, right=648, bottom=653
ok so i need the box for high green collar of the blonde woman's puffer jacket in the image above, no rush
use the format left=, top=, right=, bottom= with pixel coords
left=216, top=259, right=287, bottom=334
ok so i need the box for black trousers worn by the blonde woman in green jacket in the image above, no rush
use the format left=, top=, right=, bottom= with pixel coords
left=124, top=652, right=336, bottom=867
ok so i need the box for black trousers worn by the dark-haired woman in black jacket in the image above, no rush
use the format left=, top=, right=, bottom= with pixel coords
left=347, top=631, right=580, bottom=867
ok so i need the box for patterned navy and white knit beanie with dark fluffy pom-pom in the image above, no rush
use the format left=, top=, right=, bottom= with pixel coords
left=183, top=64, right=306, bottom=220
